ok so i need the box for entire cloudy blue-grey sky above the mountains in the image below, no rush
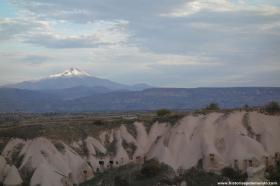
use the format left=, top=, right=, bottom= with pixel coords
left=0, top=0, right=280, bottom=87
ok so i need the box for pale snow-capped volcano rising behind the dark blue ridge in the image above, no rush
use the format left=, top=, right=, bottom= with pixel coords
left=5, top=67, right=150, bottom=94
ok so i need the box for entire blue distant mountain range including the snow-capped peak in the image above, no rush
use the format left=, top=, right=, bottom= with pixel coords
left=0, top=68, right=280, bottom=112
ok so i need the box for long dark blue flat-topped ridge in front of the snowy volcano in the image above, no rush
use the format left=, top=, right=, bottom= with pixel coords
left=0, top=87, right=280, bottom=112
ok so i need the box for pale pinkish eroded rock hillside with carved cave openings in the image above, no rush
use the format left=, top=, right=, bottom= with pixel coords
left=0, top=111, right=280, bottom=186
